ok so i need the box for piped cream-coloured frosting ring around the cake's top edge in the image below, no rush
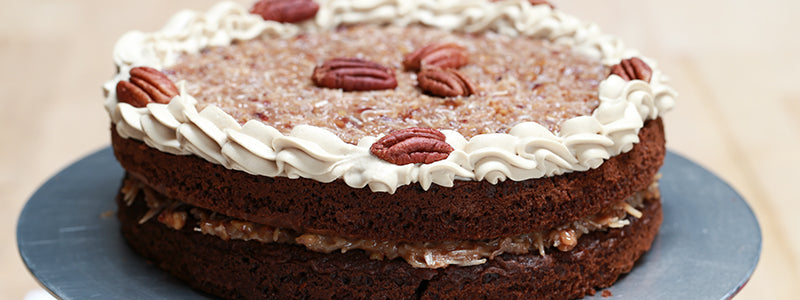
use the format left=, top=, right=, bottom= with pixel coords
left=104, top=0, right=676, bottom=193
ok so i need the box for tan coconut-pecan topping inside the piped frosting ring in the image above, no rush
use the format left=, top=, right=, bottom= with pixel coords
left=164, top=25, right=609, bottom=144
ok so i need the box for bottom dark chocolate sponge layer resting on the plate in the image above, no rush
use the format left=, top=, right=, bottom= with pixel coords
left=112, top=185, right=662, bottom=299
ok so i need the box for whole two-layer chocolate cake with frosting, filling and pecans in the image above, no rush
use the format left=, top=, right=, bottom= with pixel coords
left=104, top=0, right=675, bottom=299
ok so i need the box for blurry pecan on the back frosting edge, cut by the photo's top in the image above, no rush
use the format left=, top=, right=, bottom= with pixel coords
left=250, top=0, right=319, bottom=23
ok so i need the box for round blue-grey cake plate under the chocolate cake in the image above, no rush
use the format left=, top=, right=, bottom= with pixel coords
left=17, top=148, right=761, bottom=300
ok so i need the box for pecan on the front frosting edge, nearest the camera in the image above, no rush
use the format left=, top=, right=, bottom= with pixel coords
left=369, top=127, right=453, bottom=165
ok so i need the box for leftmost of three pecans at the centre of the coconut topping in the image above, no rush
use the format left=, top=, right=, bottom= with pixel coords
left=311, top=58, right=397, bottom=91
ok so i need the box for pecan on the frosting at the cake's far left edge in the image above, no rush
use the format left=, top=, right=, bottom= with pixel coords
left=117, top=67, right=178, bottom=107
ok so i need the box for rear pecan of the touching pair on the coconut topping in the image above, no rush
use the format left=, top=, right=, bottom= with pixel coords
left=403, top=43, right=469, bottom=71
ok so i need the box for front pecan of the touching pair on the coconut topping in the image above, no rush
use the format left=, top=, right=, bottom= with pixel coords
left=417, top=69, right=476, bottom=97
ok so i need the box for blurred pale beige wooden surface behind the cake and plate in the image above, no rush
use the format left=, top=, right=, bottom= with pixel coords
left=0, top=0, right=800, bottom=299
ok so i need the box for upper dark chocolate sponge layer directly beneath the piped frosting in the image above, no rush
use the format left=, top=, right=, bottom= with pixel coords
left=111, top=119, right=666, bottom=242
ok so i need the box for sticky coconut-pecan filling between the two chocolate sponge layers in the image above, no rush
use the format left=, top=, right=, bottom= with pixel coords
left=121, top=176, right=659, bottom=268
